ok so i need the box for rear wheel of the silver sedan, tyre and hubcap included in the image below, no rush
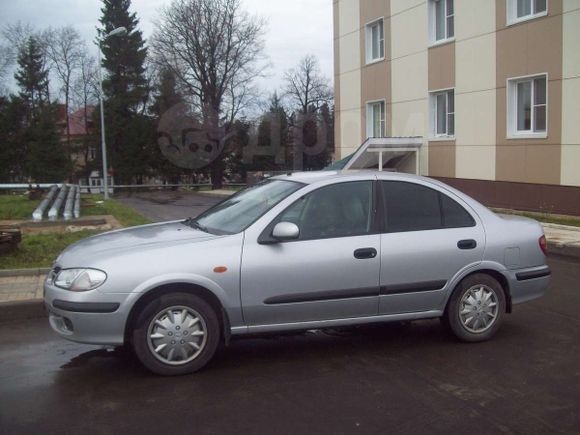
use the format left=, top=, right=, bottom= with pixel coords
left=443, top=273, right=506, bottom=342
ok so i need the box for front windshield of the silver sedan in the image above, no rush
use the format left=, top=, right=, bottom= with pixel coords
left=185, top=180, right=304, bottom=234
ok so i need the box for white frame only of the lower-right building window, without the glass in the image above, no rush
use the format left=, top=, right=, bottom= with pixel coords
left=506, top=73, right=550, bottom=139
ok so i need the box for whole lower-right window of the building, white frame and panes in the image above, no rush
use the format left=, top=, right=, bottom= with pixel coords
left=508, top=75, right=548, bottom=136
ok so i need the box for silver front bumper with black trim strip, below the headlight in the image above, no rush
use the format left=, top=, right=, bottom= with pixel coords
left=44, top=282, right=133, bottom=346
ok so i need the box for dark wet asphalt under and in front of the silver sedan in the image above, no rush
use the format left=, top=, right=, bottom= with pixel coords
left=0, top=258, right=580, bottom=434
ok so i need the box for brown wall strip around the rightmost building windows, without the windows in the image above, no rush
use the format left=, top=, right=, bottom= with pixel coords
left=496, top=0, right=562, bottom=184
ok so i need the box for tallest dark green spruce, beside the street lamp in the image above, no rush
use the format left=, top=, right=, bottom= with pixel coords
left=97, top=0, right=150, bottom=184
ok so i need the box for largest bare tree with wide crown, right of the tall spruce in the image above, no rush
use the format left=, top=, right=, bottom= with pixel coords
left=152, top=0, right=265, bottom=188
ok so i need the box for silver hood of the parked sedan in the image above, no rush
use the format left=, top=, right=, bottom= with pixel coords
left=56, top=221, right=221, bottom=267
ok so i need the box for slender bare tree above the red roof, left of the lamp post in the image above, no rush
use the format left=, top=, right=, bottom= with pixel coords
left=43, top=26, right=86, bottom=146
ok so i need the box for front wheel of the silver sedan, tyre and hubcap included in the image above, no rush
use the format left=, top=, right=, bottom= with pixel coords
left=132, top=293, right=221, bottom=376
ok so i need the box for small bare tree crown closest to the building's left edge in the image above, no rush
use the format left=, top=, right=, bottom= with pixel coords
left=284, top=55, right=333, bottom=115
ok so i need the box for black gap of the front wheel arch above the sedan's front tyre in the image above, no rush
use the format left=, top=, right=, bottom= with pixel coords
left=124, top=281, right=231, bottom=344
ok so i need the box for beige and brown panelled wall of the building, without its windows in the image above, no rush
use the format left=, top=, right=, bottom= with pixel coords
left=334, top=0, right=580, bottom=192
